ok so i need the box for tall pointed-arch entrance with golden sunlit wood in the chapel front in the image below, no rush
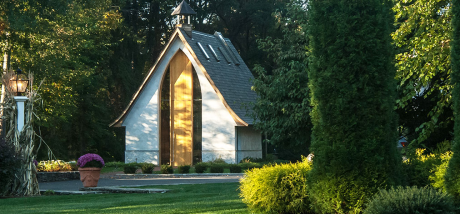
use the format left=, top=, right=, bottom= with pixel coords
left=160, top=51, right=201, bottom=166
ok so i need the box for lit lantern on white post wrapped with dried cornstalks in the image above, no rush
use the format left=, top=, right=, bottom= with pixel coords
left=9, top=69, right=29, bottom=132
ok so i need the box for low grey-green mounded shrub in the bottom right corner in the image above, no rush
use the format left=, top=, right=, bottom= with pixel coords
left=364, top=186, right=456, bottom=214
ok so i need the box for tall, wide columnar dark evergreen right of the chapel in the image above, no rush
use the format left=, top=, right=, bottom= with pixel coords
left=308, top=0, right=401, bottom=213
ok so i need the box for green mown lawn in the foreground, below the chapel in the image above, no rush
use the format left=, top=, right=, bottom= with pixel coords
left=0, top=183, right=249, bottom=214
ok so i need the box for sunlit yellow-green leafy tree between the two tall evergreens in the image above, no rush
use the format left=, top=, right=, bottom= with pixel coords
left=392, top=0, right=453, bottom=150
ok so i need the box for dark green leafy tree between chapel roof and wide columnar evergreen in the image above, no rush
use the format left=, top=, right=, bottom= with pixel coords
left=252, top=0, right=312, bottom=160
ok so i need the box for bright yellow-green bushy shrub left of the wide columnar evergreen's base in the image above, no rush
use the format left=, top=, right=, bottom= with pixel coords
left=240, top=160, right=311, bottom=214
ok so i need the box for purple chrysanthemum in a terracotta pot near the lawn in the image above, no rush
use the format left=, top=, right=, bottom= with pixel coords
left=77, top=153, right=105, bottom=187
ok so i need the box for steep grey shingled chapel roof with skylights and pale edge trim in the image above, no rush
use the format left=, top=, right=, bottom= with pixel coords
left=110, top=28, right=256, bottom=127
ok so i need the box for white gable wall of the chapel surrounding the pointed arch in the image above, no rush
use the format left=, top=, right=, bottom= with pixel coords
left=122, top=38, right=236, bottom=165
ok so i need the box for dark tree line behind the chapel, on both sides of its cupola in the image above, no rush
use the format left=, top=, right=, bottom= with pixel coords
left=0, top=0, right=287, bottom=160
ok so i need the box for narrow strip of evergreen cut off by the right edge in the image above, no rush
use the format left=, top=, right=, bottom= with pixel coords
left=444, top=0, right=460, bottom=200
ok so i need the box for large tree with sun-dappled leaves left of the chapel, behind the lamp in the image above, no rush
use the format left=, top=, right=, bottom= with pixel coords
left=2, top=0, right=123, bottom=159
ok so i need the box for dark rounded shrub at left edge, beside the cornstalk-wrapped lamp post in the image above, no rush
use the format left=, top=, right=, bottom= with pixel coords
left=0, top=138, right=21, bottom=196
